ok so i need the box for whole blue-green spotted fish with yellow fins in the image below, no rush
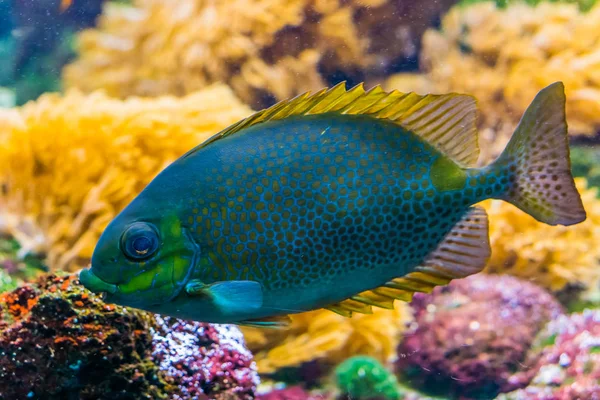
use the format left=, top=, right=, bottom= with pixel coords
left=79, top=82, right=586, bottom=328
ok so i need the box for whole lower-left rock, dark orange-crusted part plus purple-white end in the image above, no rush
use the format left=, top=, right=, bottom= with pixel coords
left=0, top=275, right=258, bottom=400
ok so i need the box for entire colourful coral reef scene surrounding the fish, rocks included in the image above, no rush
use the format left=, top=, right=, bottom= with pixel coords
left=0, top=0, right=600, bottom=400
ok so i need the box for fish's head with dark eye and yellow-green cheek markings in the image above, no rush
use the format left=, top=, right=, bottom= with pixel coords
left=79, top=209, right=199, bottom=309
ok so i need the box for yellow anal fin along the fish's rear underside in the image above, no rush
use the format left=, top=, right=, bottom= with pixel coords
left=326, top=207, right=490, bottom=317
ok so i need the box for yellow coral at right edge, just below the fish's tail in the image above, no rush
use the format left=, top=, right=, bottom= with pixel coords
left=482, top=178, right=600, bottom=291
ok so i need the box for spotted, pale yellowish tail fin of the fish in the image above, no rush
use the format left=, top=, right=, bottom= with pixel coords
left=493, top=82, right=586, bottom=225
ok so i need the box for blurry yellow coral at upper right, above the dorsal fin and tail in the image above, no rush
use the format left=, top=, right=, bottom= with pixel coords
left=386, top=2, right=600, bottom=160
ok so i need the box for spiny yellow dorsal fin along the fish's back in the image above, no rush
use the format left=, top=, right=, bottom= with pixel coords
left=184, top=82, right=479, bottom=167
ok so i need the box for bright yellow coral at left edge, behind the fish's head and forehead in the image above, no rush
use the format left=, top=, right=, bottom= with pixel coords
left=0, top=85, right=251, bottom=269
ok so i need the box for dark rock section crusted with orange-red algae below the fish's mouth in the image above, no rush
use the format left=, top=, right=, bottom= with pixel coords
left=0, top=275, right=167, bottom=399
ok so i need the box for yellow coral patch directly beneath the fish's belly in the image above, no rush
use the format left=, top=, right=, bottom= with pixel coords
left=242, top=302, right=411, bottom=373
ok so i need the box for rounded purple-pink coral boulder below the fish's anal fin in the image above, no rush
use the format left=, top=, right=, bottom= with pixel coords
left=397, top=274, right=563, bottom=399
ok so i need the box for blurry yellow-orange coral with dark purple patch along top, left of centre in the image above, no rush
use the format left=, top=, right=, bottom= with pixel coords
left=64, top=0, right=454, bottom=107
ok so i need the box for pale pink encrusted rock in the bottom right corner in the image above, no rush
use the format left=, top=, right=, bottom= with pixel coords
left=498, top=310, right=600, bottom=400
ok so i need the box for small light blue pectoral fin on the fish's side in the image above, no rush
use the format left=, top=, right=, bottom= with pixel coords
left=185, top=280, right=263, bottom=313
